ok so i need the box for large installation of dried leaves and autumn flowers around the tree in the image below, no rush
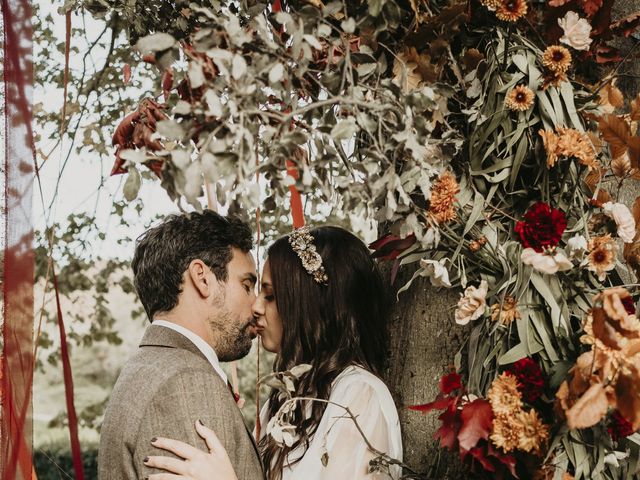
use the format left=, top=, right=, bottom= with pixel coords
left=87, top=0, right=640, bottom=480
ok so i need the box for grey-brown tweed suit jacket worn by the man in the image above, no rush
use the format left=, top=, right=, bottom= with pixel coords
left=98, top=325, right=264, bottom=480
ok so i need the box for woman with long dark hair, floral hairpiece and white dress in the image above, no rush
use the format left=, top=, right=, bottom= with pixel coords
left=145, top=227, right=402, bottom=480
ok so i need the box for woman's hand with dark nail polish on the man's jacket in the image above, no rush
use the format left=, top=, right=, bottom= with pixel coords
left=144, top=420, right=238, bottom=480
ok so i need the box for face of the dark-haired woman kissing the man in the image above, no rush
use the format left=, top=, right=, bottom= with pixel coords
left=253, top=261, right=282, bottom=353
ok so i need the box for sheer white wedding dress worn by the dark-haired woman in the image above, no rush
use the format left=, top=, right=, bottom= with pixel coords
left=260, top=366, right=402, bottom=480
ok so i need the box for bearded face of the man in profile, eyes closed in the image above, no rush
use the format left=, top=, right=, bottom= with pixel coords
left=209, top=248, right=257, bottom=362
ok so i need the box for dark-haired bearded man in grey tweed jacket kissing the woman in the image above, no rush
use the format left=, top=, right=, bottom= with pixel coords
left=98, top=210, right=263, bottom=480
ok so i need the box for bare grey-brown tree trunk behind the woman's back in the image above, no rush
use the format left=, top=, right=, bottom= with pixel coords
left=385, top=267, right=468, bottom=479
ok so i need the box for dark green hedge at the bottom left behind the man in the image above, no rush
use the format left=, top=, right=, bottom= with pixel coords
left=33, top=445, right=98, bottom=480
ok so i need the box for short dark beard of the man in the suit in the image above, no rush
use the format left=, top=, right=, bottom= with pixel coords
left=209, top=307, right=254, bottom=362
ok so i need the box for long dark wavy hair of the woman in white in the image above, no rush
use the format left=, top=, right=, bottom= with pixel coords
left=260, top=227, right=389, bottom=480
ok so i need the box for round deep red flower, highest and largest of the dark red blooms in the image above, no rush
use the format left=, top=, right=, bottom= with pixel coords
left=515, top=202, right=567, bottom=252
